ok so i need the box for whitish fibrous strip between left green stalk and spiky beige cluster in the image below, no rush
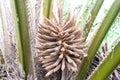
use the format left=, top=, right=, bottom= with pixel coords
left=26, top=0, right=43, bottom=80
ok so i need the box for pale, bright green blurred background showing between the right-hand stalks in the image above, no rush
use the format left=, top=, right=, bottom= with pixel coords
left=64, top=0, right=120, bottom=50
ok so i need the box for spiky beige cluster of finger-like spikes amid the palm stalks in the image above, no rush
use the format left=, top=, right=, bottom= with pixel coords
left=37, top=8, right=87, bottom=77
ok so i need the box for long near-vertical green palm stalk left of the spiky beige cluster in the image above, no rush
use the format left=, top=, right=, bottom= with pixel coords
left=15, top=0, right=34, bottom=77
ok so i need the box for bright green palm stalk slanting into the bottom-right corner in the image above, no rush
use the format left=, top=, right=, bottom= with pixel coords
left=89, top=42, right=120, bottom=80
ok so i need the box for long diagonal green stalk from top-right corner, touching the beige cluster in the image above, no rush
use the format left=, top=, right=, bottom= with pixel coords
left=77, top=0, right=120, bottom=80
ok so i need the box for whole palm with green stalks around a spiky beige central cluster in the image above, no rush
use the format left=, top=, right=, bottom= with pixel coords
left=0, top=0, right=120, bottom=80
